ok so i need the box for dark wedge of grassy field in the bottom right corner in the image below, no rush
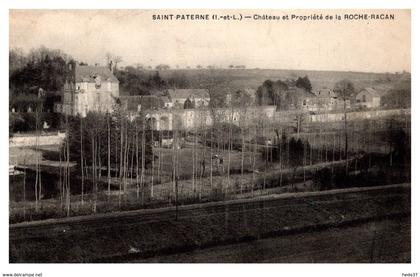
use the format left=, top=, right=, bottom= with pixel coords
left=139, top=217, right=411, bottom=263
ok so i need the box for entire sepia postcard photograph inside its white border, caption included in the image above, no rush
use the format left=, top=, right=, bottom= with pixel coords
left=6, top=9, right=416, bottom=264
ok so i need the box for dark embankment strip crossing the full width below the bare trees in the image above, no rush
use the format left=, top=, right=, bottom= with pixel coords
left=9, top=186, right=410, bottom=241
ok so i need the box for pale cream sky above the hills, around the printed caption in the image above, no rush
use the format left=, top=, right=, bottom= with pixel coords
left=9, top=10, right=411, bottom=72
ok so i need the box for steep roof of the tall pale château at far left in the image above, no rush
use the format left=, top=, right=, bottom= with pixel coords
left=74, top=64, right=118, bottom=83
